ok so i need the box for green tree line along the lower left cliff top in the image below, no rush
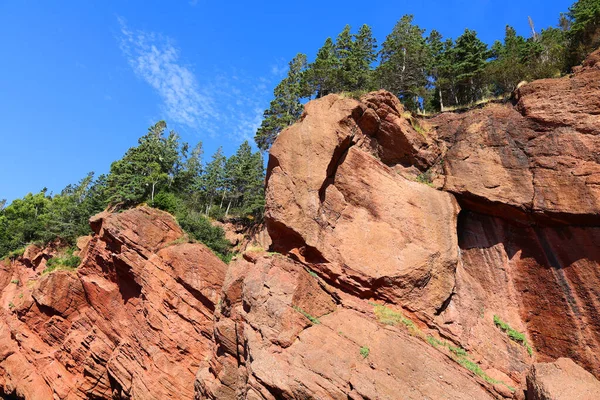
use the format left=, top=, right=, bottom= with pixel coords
left=0, top=121, right=264, bottom=258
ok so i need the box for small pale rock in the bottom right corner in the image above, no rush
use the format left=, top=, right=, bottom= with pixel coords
left=527, top=358, right=600, bottom=400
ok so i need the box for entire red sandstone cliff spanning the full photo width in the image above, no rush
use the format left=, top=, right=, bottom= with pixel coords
left=0, top=51, right=600, bottom=400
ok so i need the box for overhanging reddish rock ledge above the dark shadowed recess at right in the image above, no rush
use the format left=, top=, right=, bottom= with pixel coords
left=430, top=51, right=600, bottom=225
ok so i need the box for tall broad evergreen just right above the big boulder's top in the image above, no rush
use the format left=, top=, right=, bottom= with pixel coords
left=377, top=15, right=431, bottom=110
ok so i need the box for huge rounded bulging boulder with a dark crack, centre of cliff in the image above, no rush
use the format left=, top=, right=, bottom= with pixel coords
left=265, top=91, right=459, bottom=316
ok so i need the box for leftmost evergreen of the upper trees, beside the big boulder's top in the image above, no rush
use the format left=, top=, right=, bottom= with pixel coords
left=254, top=53, right=306, bottom=150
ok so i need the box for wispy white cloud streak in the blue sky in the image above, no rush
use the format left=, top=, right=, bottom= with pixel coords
left=119, top=18, right=271, bottom=145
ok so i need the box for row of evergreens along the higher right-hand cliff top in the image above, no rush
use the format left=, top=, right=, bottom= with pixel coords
left=255, top=0, right=600, bottom=150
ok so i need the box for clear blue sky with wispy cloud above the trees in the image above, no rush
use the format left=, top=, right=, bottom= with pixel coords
left=0, top=0, right=572, bottom=201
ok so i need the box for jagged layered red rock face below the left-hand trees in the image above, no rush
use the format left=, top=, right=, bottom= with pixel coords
left=0, top=207, right=226, bottom=400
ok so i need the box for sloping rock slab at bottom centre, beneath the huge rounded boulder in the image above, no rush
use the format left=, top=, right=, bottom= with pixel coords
left=197, top=254, right=496, bottom=400
